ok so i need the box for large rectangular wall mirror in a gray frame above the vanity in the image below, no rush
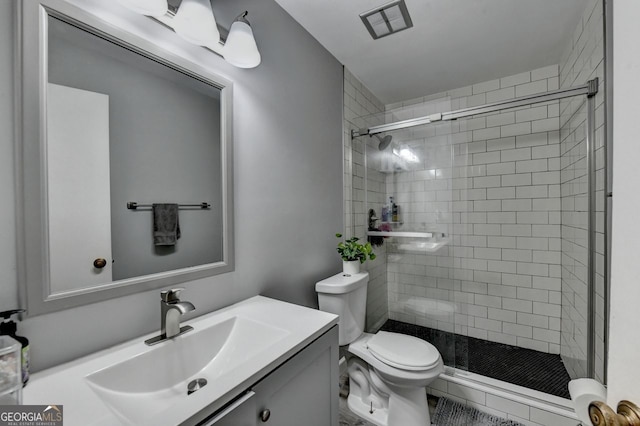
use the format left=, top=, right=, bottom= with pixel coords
left=18, top=0, right=233, bottom=315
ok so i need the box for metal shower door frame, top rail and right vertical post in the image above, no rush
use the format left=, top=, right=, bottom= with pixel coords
left=351, top=77, right=610, bottom=378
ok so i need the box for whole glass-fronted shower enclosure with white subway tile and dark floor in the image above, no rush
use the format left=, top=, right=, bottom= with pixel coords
left=348, top=78, right=606, bottom=398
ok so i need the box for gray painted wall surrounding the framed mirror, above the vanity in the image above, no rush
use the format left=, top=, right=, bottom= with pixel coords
left=0, top=0, right=342, bottom=371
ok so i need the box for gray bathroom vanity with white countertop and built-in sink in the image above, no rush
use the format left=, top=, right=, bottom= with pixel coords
left=23, top=296, right=339, bottom=426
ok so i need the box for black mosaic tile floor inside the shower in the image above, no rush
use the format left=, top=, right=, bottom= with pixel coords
left=381, top=320, right=570, bottom=398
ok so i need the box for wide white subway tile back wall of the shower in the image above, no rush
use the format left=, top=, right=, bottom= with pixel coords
left=378, top=65, right=561, bottom=354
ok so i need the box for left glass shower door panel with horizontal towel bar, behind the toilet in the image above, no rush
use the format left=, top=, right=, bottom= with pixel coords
left=365, top=100, right=467, bottom=367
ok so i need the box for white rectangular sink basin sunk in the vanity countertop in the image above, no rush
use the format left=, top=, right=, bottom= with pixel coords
left=85, top=316, right=289, bottom=424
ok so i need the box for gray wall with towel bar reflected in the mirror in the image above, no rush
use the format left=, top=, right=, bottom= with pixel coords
left=49, top=18, right=222, bottom=280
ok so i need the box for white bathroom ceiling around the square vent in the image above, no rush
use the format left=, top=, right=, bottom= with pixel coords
left=276, top=0, right=592, bottom=104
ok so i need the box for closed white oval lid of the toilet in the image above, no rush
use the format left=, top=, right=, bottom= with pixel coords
left=367, top=331, right=440, bottom=370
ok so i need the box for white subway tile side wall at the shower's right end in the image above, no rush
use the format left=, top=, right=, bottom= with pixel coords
left=560, top=0, right=606, bottom=382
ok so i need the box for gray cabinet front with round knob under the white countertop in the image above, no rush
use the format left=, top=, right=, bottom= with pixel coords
left=200, top=326, right=339, bottom=426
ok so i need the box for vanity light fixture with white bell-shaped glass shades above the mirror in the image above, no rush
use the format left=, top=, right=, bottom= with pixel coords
left=118, top=0, right=262, bottom=68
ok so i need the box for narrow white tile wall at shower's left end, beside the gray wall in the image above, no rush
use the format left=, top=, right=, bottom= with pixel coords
left=336, top=68, right=389, bottom=331
